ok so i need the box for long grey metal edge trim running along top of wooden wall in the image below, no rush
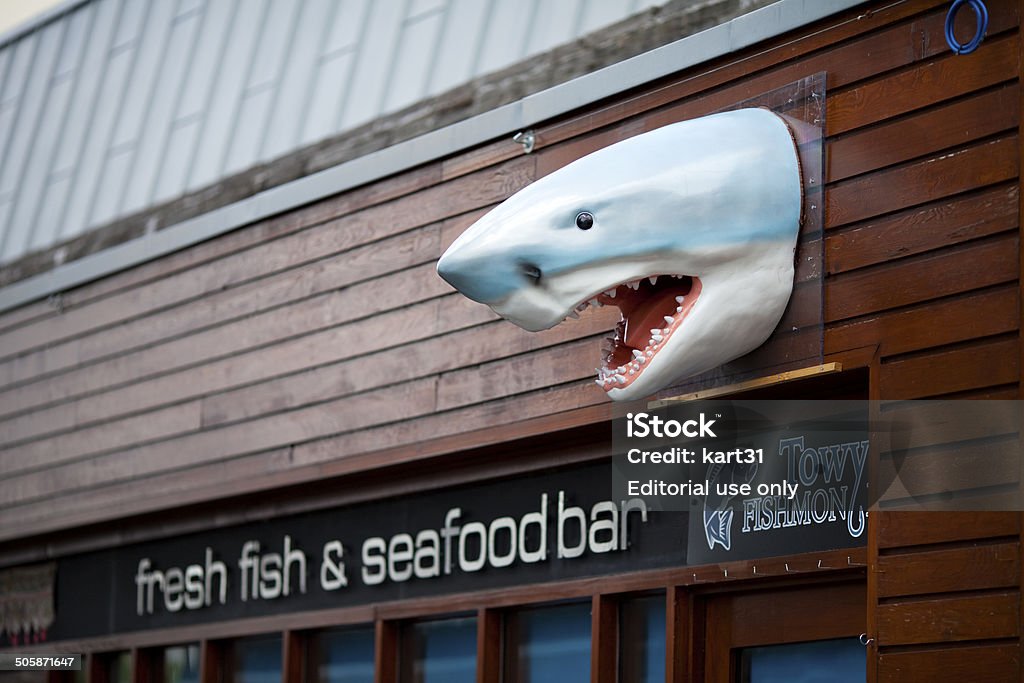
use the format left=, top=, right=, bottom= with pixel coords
left=0, top=0, right=864, bottom=311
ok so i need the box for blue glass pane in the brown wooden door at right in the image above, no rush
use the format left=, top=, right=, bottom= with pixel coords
left=739, top=638, right=867, bottom=683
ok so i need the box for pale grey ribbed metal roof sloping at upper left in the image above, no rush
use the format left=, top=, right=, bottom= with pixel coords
left=0, top=0, right=696, bottom=262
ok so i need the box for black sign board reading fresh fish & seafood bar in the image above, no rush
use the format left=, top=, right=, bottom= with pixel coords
left=48, top=461, right=687, bottom=640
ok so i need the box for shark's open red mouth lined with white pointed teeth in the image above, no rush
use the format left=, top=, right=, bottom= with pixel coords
left=575, top=274, right=700, bottom=391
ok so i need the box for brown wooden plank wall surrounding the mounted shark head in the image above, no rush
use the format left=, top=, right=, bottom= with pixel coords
left=0, top=0, right=1021, bottom=681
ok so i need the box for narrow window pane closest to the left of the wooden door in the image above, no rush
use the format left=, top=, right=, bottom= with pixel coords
left=618, top=593, right=666, bottom=683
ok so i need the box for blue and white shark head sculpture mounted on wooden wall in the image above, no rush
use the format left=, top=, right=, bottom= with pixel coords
left=437, top=109, right=803, bottom=400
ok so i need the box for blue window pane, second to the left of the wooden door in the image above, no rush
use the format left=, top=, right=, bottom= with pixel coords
left=505, top=602, right=590, bottom=683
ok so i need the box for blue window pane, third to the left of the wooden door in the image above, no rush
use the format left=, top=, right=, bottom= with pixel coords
left=398, top=616, right=476, bottom=683
